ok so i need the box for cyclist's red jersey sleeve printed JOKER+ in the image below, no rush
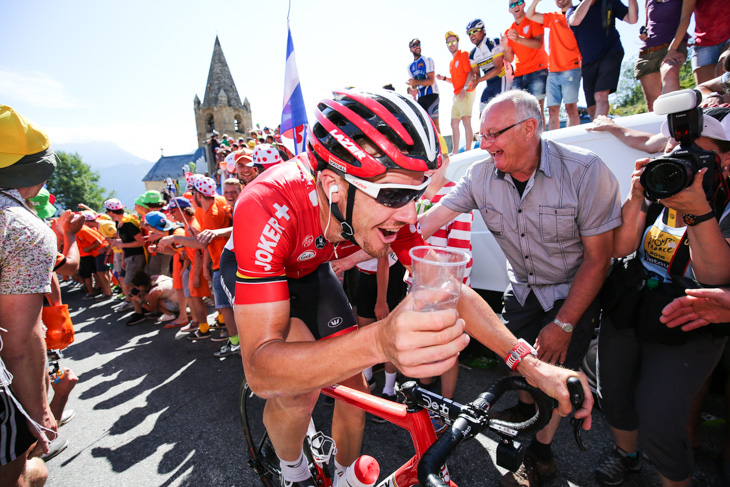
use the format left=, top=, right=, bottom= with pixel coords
left=233, top=184, right=296, bottom=305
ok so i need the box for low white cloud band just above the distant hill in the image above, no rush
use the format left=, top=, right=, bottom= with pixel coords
left=44, top=122, right=195, bottom=162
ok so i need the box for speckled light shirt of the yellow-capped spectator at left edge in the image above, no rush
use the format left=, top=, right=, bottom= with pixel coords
left=0, top=189, right=56, bottom=294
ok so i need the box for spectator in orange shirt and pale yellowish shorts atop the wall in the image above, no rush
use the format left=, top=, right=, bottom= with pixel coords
left=436, top=31, right=476, bottom=154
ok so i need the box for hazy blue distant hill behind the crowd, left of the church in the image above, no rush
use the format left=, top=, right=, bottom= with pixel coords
left=53, top=142, right=154, bottom=208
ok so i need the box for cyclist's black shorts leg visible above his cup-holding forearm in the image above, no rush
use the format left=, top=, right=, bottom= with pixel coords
left=288, top=263, right=357, bottom=340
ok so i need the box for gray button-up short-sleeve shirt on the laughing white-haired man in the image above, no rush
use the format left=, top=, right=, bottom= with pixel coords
left=441, top=140, right=621, bottom=310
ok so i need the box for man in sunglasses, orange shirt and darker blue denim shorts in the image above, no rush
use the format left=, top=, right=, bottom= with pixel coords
left=502, top=0, right=548, bottom=125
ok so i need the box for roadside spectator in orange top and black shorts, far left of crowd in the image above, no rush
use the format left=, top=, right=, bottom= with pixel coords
left=76, top=211, right=112, bottom=299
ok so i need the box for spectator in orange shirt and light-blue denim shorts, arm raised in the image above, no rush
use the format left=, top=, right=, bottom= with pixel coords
left=525, top=0, right=582, bottom=130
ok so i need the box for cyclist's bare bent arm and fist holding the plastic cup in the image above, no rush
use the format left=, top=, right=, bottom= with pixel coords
left=235, top=297, right=469, bottom=398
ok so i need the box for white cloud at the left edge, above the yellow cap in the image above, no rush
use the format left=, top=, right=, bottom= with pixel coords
left=0, top=69, right=78, bottom=108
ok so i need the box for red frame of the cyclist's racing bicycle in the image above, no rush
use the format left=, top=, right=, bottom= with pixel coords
left=322, top=385, right=457, bottom=487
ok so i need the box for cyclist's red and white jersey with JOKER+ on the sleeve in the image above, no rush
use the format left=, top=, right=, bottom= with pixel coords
left=233, top=154, right=425, bottom=304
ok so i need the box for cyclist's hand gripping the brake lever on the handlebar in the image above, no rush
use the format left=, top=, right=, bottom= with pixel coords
left=517, top=357, right=593, bottom=430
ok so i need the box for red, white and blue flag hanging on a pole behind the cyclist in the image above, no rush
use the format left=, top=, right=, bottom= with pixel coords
left=281, top=21, right=307, bottom=154
